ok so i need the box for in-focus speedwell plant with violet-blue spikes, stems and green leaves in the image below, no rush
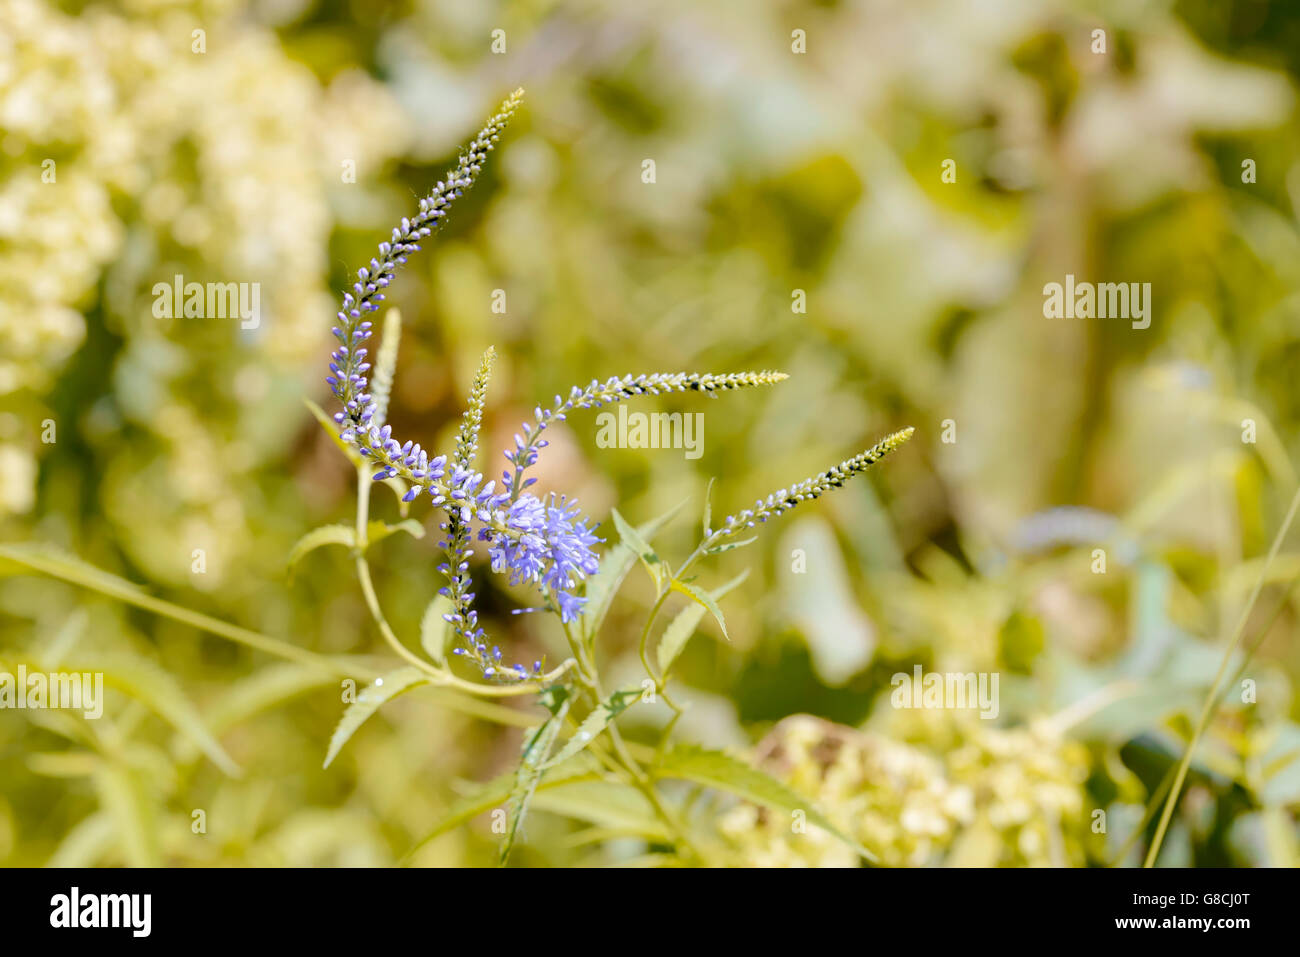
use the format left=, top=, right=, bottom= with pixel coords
left=309, top=90, right=913, bottom=862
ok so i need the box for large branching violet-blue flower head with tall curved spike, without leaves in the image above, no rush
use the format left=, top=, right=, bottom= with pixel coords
left=325, top=90, right=790, bottom=680
